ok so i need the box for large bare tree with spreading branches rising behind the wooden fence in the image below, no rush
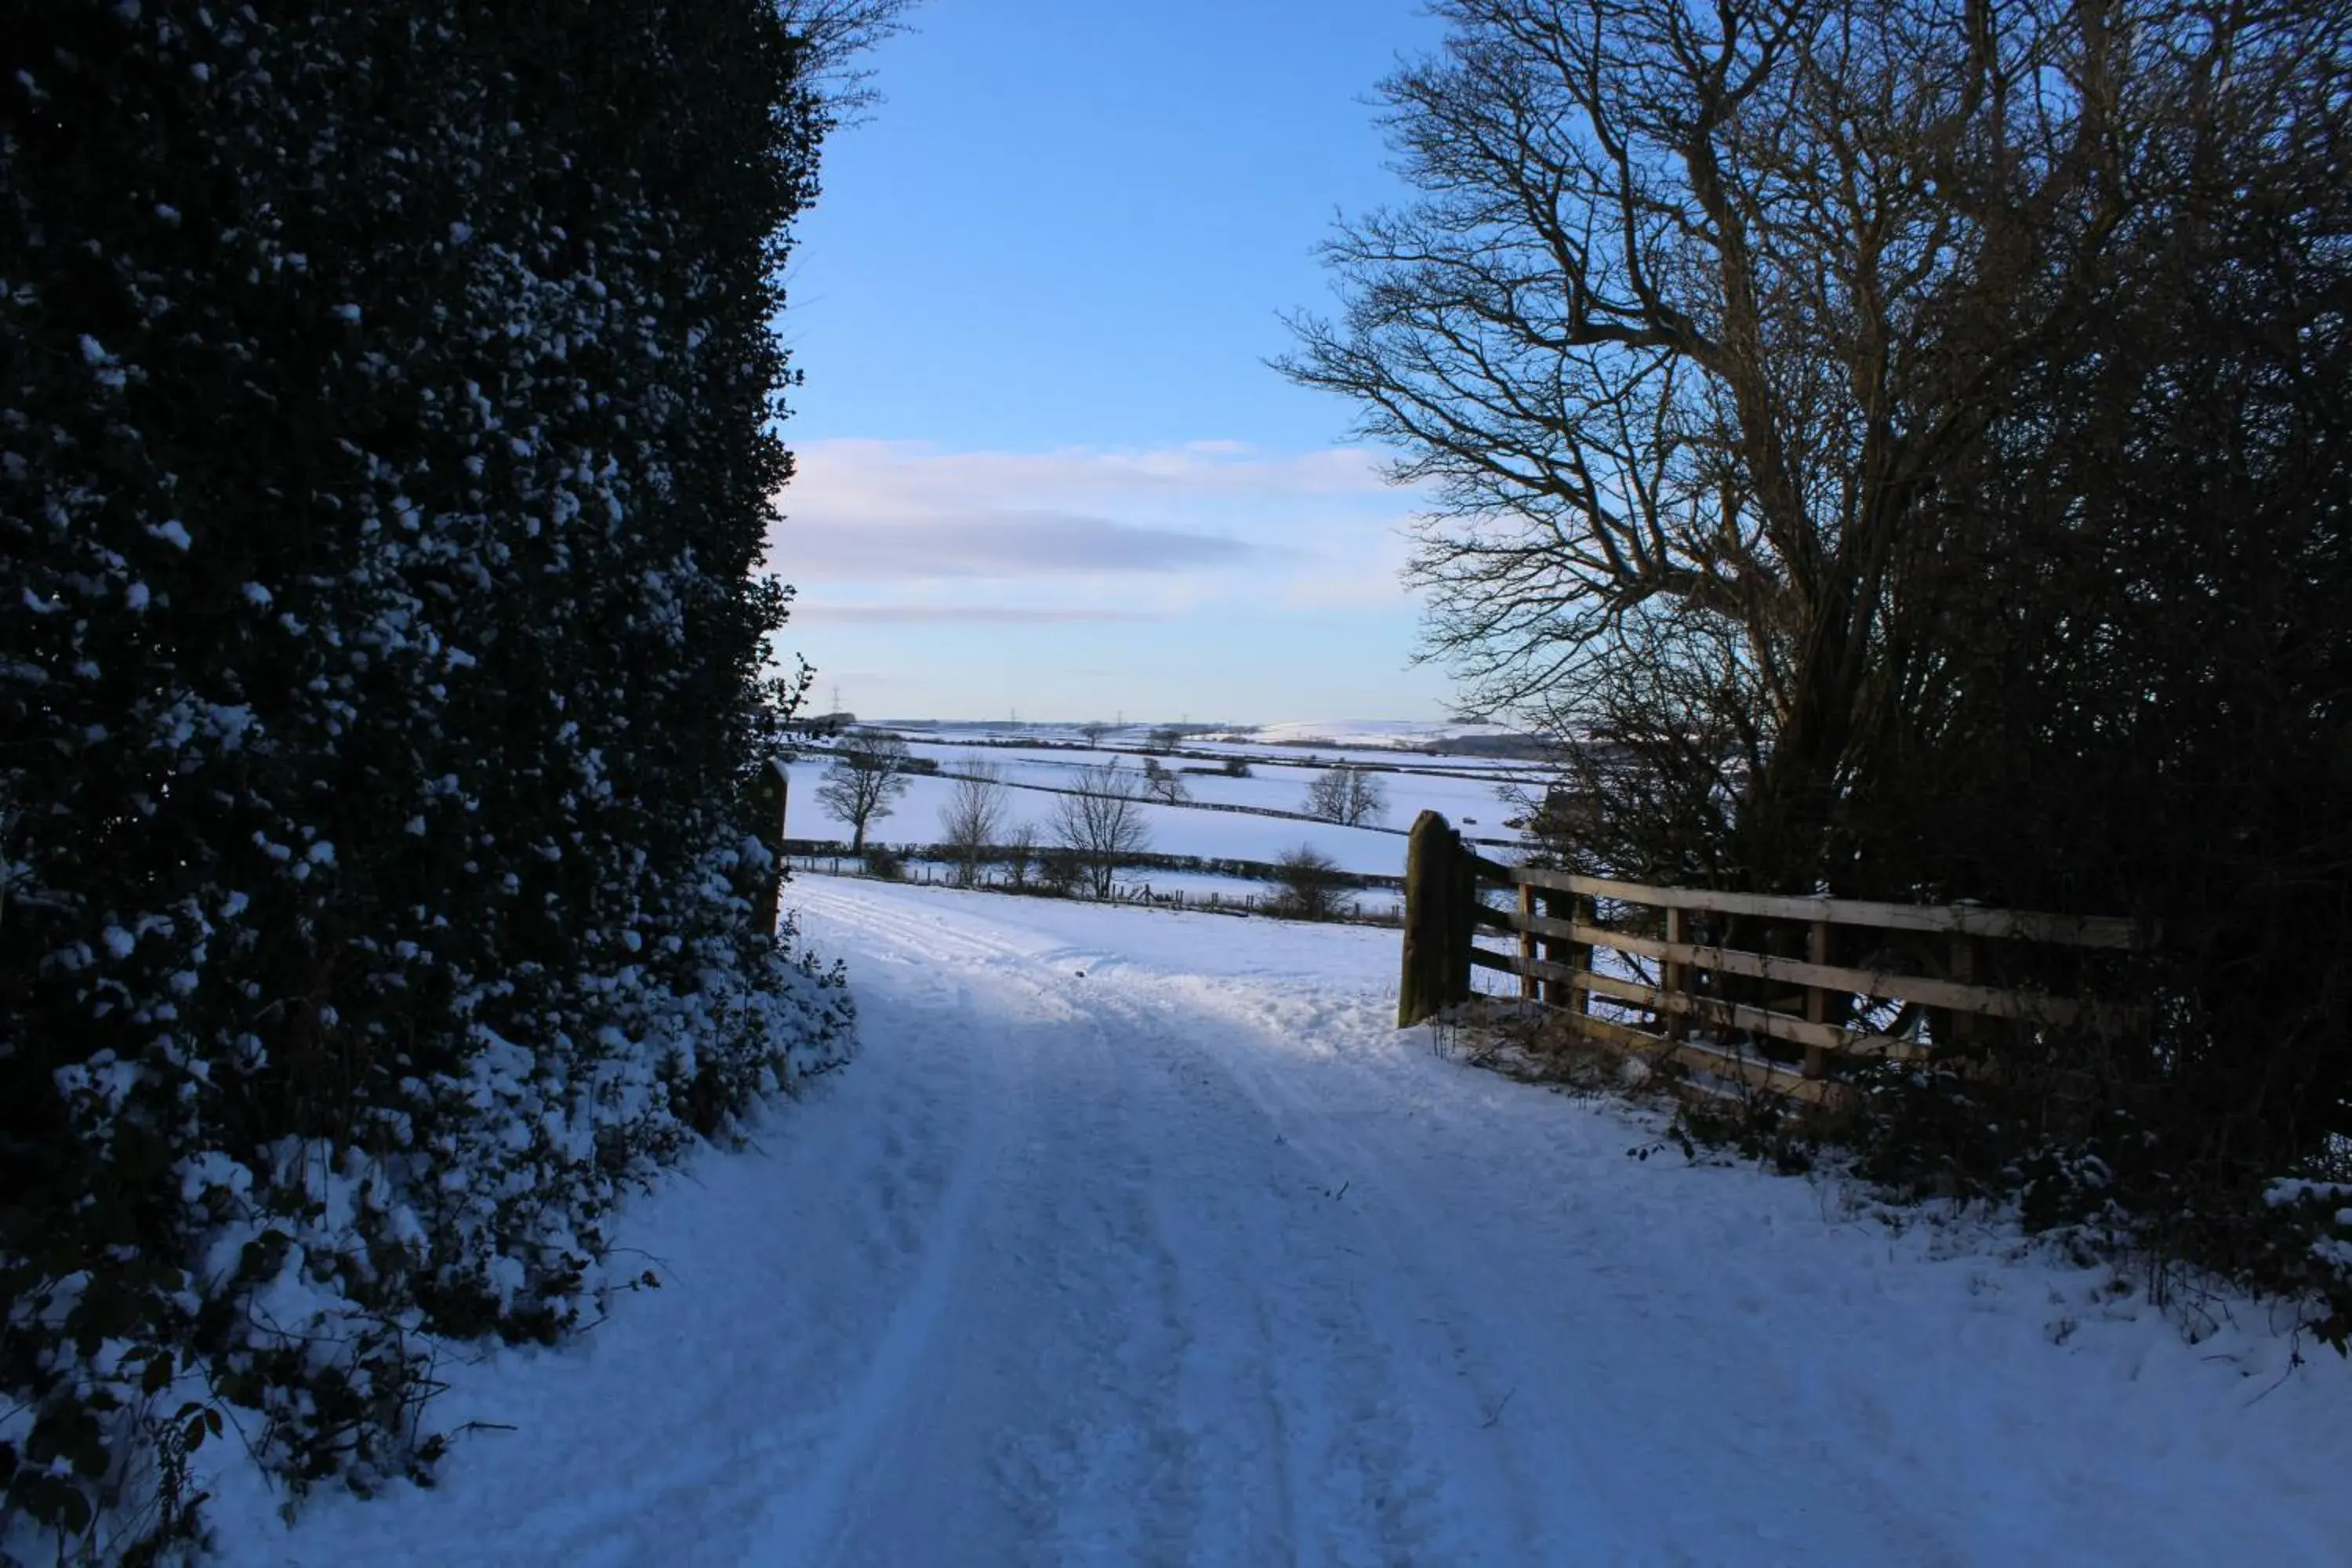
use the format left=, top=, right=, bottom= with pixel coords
left=1282, top=0, right=2145, bottom=881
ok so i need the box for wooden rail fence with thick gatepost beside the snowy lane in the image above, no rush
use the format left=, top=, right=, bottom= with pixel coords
left=1397, top=811, right=2157, bottom=1102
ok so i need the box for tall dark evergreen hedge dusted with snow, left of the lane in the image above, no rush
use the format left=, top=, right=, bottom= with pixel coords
left=0, top=0, right=849, bottom=1552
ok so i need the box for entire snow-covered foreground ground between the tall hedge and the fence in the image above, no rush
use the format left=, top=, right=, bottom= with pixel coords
left=198, top=877, right=2352, bottom=1568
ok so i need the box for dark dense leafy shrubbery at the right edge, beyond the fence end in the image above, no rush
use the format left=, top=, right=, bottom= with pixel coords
left=1851, top=7, right=2352, bottom=1298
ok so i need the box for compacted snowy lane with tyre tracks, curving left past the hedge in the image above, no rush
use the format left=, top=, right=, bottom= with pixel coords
left=776, top=888, right=1508, bottom=1563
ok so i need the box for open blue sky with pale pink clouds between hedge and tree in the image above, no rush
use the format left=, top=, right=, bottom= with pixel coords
left=771, top=0, right=1449, bottom=722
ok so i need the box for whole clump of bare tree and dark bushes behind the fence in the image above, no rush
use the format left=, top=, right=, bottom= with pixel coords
left=1287, top=0, right=2352, bottom=1316
